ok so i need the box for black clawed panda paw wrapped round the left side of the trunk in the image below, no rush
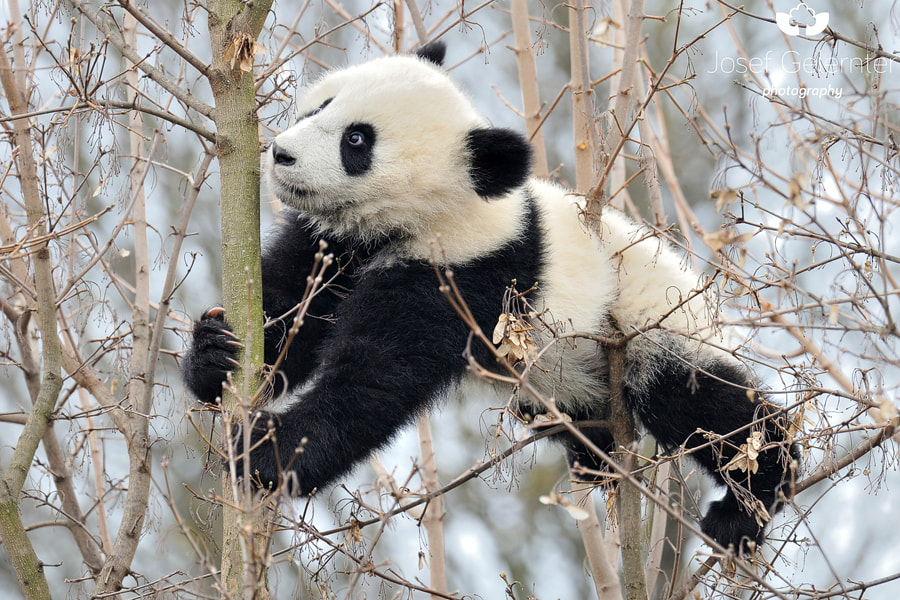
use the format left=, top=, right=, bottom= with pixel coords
left=181, top=307, right=244, bottom=404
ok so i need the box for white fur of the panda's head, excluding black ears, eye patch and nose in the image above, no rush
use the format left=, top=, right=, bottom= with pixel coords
left=269, top=57, right=484, bottom=242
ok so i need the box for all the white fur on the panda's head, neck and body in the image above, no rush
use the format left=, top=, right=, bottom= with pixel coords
left=269, top=51, right=724, bottom=409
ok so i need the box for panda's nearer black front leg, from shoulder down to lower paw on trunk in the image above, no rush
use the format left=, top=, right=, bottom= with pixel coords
left=234, top=264, right=468, bottom=494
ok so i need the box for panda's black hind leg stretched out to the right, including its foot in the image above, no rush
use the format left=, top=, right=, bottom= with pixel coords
left=626, top=346, right=796, bottom=551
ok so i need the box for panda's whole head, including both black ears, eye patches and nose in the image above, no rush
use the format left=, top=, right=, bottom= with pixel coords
left=267, top=43, right=531, bottom=241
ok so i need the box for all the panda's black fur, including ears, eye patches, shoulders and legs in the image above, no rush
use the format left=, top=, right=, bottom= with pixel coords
left=183, top=47, right=796, bottom=549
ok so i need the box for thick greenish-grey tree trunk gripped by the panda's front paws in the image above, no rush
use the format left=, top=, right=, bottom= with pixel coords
left=208, top=0, right=272, bottom=598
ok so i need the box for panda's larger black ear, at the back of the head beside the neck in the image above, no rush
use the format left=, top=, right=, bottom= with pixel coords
left=466, top=128, right=531, bottom=198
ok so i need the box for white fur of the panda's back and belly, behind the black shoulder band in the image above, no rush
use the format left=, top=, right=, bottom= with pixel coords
left=512, top=179, right=709, bottom=410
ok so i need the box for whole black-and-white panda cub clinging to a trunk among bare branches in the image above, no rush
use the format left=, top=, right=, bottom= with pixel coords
left=183, top=43, right=789, bottom=548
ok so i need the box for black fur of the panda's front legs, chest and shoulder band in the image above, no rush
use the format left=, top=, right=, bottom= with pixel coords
left=184, top=207, right=543, bottom=494
